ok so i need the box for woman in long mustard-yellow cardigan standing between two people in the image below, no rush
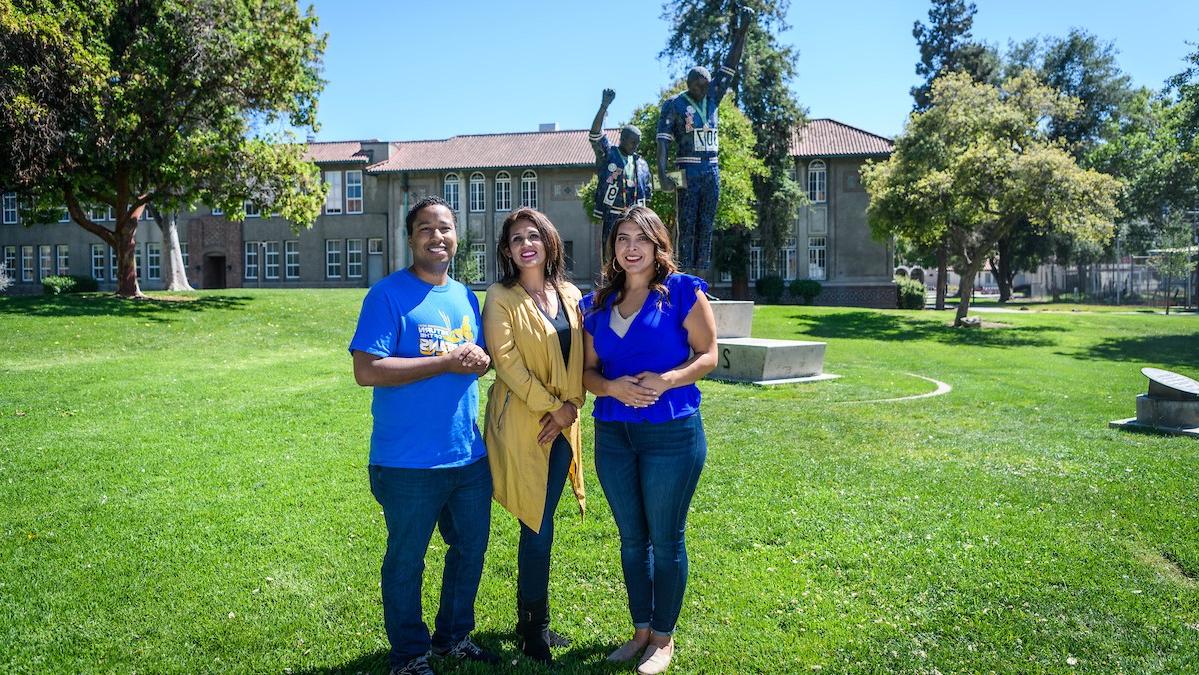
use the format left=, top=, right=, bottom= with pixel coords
left=483, top=209, right=585, bottom=663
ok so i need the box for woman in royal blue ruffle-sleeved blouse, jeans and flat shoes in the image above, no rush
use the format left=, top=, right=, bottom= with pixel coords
left=582, top=206, right=716, bottom=674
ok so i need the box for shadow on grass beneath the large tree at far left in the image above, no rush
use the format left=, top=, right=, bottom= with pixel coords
left=0, top=293, right=249, bottom=321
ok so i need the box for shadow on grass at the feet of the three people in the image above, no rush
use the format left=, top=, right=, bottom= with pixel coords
left=295, top=631, right=629, bottom=675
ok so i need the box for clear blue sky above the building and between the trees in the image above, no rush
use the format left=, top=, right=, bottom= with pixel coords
left=301, top=0, right=1199, bottom=140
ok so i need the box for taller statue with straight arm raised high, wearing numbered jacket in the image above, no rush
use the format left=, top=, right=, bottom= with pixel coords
left=657, top=7, right=753, bottom=276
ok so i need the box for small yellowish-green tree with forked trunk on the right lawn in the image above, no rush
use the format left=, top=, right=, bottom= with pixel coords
left=862, top=71, right=1120, bottom=325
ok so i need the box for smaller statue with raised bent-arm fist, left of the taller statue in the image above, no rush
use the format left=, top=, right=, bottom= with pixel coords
left=588, top=89, right=653, bottom=263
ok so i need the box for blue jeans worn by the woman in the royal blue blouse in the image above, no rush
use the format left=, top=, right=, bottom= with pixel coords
left=595, top=412, right=707, bottom=634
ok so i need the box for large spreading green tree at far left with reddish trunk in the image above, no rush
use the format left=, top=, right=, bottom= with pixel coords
left=0, top=0, right=325, bottom=297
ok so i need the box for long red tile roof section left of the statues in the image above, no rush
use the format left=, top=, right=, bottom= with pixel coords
left=369, top=129, right=620, bottom=173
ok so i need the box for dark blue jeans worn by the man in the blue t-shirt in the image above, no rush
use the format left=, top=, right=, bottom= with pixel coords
left=368, top=458, right=492, bottom=667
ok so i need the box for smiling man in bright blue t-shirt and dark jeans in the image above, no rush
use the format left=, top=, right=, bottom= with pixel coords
left=350, top=197, right=499, bottom=675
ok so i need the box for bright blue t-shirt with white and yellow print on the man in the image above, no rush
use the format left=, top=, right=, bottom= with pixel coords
left=350, top=270, right=487, bottom=469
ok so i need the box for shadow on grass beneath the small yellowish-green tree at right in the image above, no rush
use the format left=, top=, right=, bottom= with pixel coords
left=791, top=312, right=1067, bottom=346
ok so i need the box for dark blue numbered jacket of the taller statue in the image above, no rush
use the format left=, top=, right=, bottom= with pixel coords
left=656, top=66, right=735, bottom=169
